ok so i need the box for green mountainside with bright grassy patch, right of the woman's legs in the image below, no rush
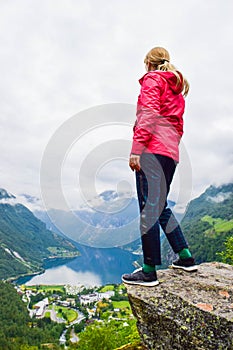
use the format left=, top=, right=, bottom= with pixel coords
left=163, top=183, right=233, bottom=264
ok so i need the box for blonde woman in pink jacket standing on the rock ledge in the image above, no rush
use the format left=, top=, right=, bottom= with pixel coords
left=122, top=47, right=197, bottom=286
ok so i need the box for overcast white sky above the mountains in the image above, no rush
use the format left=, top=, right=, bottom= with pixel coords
left=0, top=0, right=233, bottom=211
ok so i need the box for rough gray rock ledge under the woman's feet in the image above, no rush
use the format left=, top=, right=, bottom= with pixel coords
left=126, top=263, right=233, bottom=350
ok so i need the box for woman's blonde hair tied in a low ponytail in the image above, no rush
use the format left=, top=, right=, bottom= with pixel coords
left=144, top=47, right=189, bottom=96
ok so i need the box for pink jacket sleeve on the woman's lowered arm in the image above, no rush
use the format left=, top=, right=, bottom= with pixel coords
left=131, top=74, right=161, bottom=155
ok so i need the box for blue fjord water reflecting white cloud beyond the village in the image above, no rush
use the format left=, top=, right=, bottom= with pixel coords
left=17, top=245, right=139, bottom=287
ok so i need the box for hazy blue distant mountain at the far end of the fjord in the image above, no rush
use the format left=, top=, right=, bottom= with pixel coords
left=34, top=190, right=175, bottom=251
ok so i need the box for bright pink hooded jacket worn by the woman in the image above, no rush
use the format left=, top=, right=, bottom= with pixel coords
left=131, top=70, right=185, bottom=161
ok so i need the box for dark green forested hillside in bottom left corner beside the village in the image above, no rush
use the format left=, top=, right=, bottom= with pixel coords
left=0, top=281, right=64, bottom=350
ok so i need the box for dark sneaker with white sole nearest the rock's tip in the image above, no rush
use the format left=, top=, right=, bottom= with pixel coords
left=121, top=268, right=159, bottom=287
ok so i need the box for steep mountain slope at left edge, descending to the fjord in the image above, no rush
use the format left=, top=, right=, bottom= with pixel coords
left=0, top=189, right=78, bottom=279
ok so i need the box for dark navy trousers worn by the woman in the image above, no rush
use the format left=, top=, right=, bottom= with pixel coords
left=136, top=153, right=188, bottom=265
